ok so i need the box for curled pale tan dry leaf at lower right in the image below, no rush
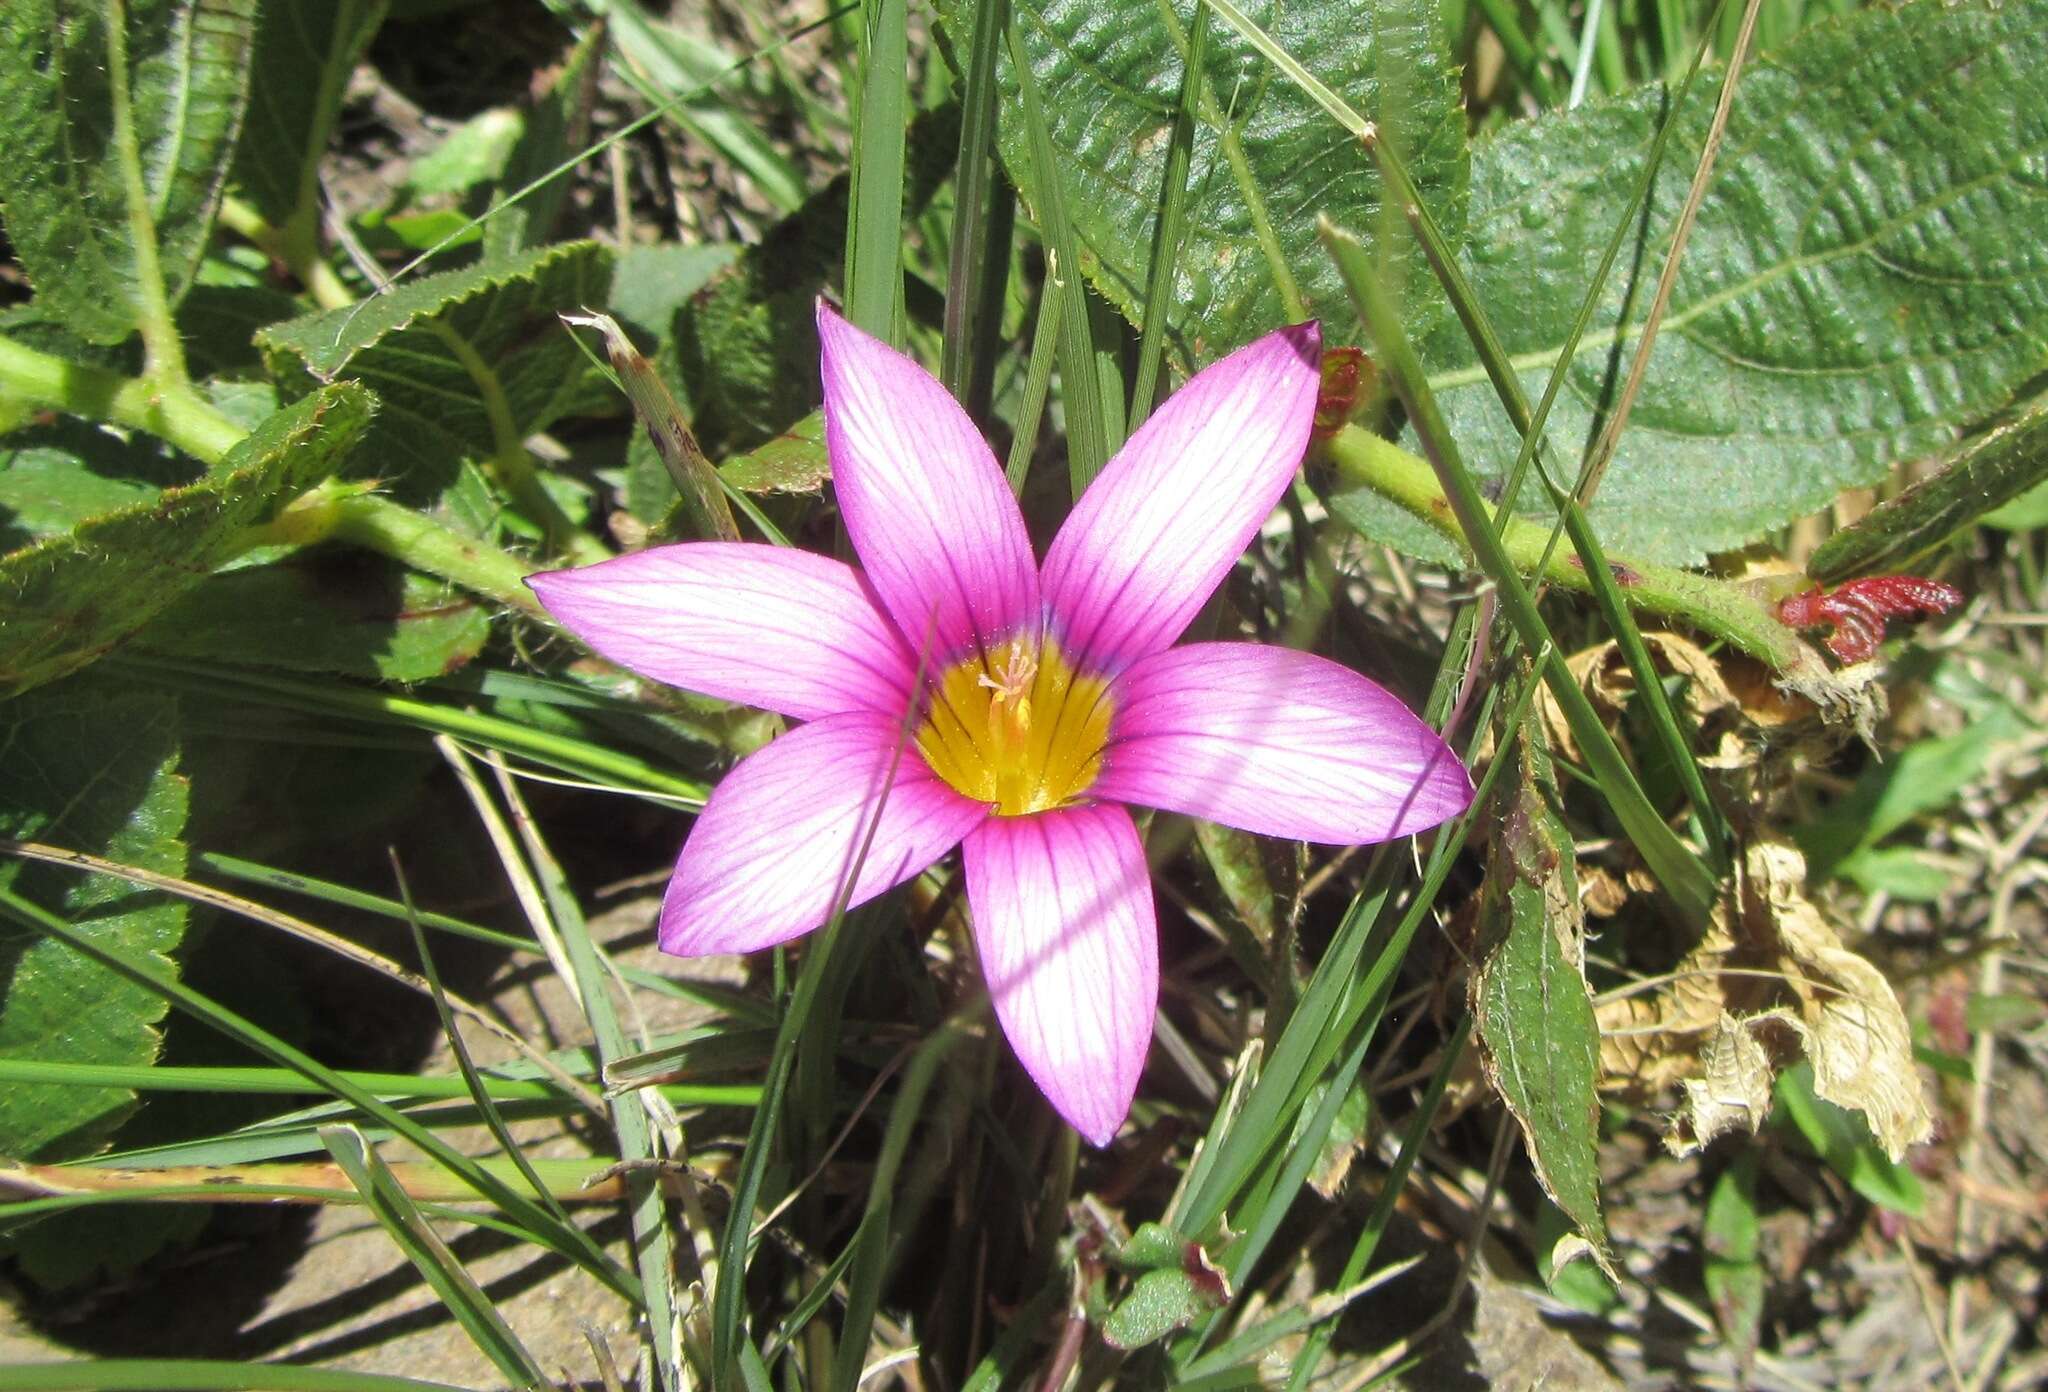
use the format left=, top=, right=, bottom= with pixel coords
left=1599, top=841, right=1933, bottom=1161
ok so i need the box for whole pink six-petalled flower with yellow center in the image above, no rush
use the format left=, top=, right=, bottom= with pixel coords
left=528, top=305, right=1473, bottom=1146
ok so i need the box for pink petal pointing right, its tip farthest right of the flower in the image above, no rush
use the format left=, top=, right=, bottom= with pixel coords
left=1087, top=643, right=1473, bottom=845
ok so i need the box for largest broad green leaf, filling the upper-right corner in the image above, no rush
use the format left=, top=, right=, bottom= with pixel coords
left=1409, top=0, right=2048, bottom=563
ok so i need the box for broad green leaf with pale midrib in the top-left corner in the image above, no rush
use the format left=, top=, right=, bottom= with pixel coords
left=0, top=0, right=256, bottom=344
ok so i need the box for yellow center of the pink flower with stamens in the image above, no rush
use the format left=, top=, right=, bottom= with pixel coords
left=918, top=637, right=1110, bottom=817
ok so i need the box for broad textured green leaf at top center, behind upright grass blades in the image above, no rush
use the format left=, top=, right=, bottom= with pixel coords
left=942, top=0, right=1466, bottom=371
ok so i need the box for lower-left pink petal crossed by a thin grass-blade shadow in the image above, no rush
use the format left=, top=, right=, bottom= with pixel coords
left=662, top=712, right=989, bottom=956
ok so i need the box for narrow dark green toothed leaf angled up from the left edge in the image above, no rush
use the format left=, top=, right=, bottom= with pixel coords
left=0, top=383, right=371, bottom=698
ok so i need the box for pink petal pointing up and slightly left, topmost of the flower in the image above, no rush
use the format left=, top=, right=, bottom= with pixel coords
left=817, top=303, right=1038, bottom=661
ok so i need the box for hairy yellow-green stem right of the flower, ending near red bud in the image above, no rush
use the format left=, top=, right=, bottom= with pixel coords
left=1321, top=426, right=1825, bottom=678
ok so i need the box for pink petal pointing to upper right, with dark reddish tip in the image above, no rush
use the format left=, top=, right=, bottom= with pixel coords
left=1042, top=323, right=1323, bottom=671
